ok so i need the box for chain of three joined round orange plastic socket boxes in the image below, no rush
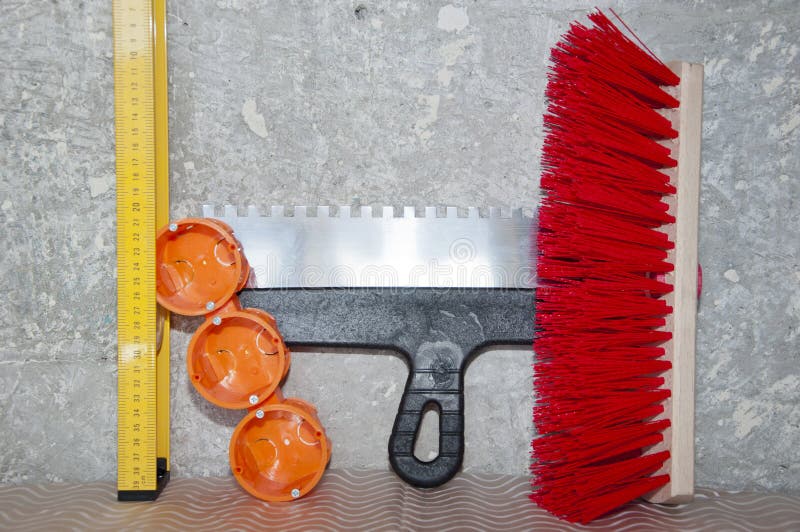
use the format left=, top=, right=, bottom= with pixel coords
left=156, top=218, right=331, bottom=501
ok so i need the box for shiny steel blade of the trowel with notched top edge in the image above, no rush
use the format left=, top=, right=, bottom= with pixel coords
left=203, top=205, right=535, bottom=288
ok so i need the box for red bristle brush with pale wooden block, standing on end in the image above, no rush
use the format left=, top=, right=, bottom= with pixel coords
left=531, top=12, right=703, bottom=523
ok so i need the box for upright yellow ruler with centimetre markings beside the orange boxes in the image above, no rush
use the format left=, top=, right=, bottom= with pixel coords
left=112, top=0, right=169, bottom=500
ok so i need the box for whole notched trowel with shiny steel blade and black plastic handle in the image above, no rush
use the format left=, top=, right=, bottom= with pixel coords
left=203, top=205, right=535, bottom=487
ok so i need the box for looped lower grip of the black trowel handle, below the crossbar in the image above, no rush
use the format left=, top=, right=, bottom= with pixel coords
left=389, top=357, right=464, bottom=488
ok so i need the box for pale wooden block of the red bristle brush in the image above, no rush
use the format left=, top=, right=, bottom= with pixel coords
left=645, top=62, right=703, bottom=504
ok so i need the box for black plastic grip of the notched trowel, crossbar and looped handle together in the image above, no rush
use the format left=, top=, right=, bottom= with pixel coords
left=239, top=288, right=535, bottom=487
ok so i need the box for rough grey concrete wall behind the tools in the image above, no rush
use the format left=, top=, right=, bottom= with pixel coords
left=0, top=0, right=800, bottom=491
